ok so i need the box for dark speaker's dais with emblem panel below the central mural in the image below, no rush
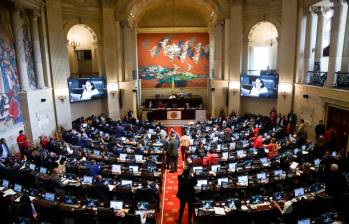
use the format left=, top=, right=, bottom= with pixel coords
left=142, top=98, right=206, bottom=126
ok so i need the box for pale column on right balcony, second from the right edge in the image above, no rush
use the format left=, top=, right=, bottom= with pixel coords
left=300, top=10, right=316, bottom=83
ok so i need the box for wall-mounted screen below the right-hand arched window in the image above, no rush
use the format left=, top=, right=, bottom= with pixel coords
left=240, top=74, right=279, bottom=98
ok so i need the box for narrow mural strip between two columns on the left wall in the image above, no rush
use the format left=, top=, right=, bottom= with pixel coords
left=22, top=14, right=36, bottom=89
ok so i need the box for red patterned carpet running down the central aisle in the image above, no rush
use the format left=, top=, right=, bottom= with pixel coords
left=161, top=128, right=188, bottom=224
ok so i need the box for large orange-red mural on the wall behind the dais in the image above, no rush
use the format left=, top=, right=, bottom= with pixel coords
left=137, top=33, right=209, bottom=88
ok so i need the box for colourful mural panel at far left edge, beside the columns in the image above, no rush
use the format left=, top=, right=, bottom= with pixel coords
left=0, top=7, right=23, bottom=130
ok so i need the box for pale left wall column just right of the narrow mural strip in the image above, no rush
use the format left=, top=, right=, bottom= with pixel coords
left=31, top=16, right=45, bottom=89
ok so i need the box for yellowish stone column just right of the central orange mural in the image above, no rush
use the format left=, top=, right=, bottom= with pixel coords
left=214, top=20, right=224, bottom=80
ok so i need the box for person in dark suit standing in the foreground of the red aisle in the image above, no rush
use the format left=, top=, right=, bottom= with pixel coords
left=177, top=168, right=197, bottom=224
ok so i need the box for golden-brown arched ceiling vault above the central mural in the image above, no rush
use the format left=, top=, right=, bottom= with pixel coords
left=116, top=0, right=230, bottom=27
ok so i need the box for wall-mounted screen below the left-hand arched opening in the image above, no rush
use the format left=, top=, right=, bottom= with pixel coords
left=68, top=77, right=107, bottom=103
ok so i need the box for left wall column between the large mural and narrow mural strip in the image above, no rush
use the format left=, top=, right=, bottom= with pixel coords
left=12, top=8, right=29, bottom=91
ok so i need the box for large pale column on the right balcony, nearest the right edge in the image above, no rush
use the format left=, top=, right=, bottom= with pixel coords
left=326, top=0, right=347, bottom=86
